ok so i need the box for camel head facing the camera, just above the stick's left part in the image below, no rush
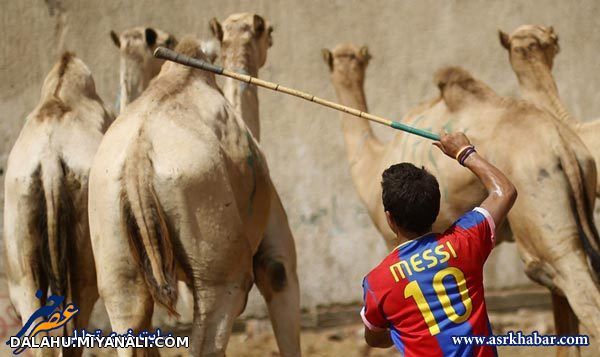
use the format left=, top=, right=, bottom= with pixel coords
left=210, top=13, right=273, bottom=71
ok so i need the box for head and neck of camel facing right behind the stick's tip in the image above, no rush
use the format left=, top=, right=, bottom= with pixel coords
left=110, top=27, right=177, bottom=112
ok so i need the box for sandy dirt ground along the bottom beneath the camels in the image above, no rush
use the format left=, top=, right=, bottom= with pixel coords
left=83, top=309, right=598, bottom=357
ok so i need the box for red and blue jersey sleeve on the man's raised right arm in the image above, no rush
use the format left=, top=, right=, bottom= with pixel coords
left=450, top=207, right=496, bottom=264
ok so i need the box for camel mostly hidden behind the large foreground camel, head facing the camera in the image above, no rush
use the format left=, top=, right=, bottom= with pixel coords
left=210, top=13, right=300, bottom=356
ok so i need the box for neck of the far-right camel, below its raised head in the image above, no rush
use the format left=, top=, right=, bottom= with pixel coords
left=517, top=62, right=578, bottom=126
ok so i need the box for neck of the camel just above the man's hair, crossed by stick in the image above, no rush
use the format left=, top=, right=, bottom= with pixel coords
left=334, top=80, right=383, bottom=182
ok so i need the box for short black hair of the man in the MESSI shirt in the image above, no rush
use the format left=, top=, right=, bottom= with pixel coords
left=381, top=162, right=440, bottom=234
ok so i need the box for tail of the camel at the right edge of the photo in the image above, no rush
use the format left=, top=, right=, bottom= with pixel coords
left=558, top=132, right=600, bottom=277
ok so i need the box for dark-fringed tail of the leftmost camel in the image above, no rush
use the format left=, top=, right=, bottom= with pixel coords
left=37, top=158, right=76, bottom=298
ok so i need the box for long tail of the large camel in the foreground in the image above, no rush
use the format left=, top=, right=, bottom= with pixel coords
left=121, top=143, right=179, bottom=316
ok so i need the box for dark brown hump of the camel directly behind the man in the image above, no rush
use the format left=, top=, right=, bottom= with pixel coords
left=434, top=67, right=494, bottom=111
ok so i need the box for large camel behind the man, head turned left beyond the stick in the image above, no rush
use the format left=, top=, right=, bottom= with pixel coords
left=323, top=45, right=600, bottom=354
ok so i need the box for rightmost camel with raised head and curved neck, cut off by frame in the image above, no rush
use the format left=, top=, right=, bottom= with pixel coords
left=499, top=25, right=600, bottom=224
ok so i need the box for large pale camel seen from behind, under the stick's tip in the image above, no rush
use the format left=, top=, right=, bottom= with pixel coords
left=89, top=38, right=298, bottom=356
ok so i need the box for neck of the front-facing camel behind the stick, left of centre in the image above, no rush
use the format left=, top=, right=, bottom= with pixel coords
left=223, top=53, right=260, bottom=141
